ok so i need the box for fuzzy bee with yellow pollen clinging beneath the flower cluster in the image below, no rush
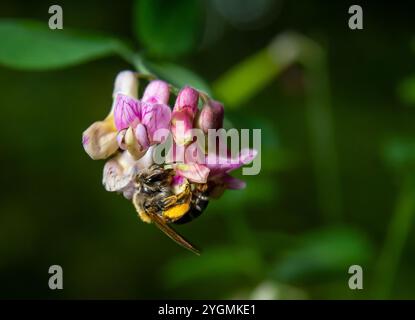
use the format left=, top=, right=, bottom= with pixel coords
left=132, top=164, right=209, bottom=254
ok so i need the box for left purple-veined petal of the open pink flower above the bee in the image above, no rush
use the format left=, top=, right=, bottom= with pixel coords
left=114, top=94, right=140, bottom=131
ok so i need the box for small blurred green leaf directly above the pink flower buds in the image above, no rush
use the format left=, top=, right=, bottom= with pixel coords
left=146, top=62, right=211, bottom=94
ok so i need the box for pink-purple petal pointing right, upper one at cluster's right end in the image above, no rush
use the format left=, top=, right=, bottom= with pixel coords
left=205, top=149, right=257, bottom=177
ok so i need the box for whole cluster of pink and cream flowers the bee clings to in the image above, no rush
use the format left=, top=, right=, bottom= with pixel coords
left=82, top=71, right=257, bottom=204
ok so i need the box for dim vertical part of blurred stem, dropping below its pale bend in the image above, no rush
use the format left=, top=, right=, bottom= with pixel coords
left=303, top=47, right=342, bottom=222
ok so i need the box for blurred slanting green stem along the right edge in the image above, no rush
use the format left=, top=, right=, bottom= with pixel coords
left=373, top=175, right=415, bottom=299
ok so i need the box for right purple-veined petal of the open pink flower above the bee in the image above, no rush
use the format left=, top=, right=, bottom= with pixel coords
left=141, top=103, right=171, bottom=143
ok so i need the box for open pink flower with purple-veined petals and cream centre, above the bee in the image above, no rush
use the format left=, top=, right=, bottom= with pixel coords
left=114, top=80, right=171, bottom=158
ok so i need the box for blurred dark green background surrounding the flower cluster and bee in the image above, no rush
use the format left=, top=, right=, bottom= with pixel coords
left=0, top=0, right=415, bottom=299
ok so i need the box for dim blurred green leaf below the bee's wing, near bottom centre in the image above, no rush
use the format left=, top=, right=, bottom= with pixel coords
left=164, top=247, right=262, bottom=288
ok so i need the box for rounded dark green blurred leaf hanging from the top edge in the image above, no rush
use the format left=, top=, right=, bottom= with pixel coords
left=134, top=0, right=202, bottom=57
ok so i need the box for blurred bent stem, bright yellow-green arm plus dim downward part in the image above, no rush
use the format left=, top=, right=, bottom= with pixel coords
left=213, top=33, right=342, bottom=221
